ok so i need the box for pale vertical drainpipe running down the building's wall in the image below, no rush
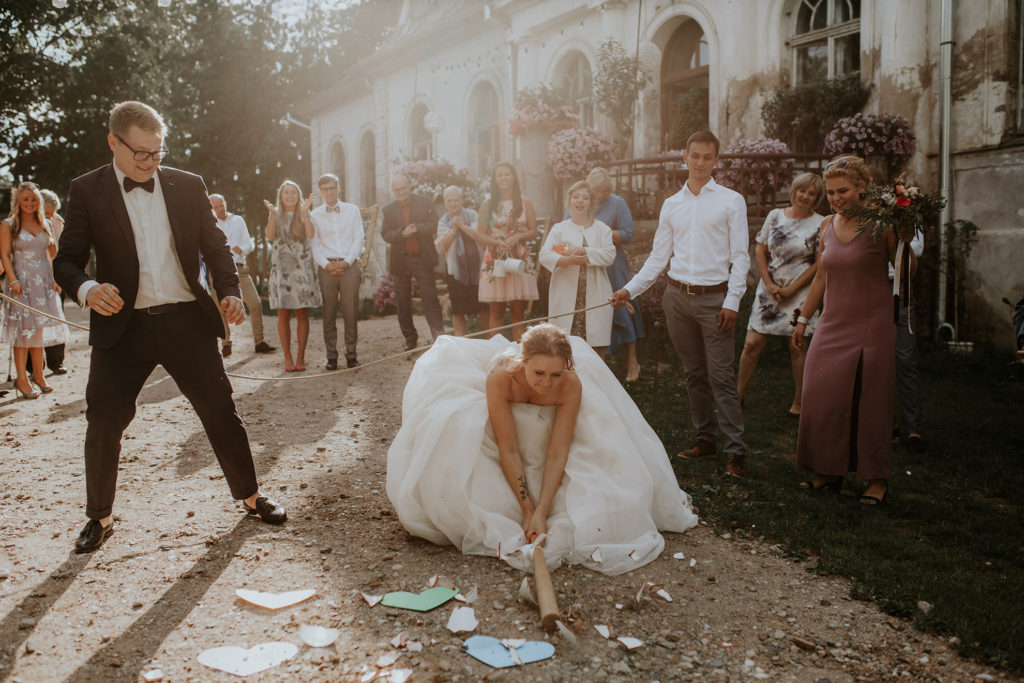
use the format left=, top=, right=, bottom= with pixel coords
left=935, top=0, right=956, bottom=341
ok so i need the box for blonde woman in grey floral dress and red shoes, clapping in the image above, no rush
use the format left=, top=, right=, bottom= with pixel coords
left=263, top=180, right=324, bottom=373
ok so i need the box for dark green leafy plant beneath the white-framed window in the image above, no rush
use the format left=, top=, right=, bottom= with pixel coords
left=761, top=74, right=871, bottom=153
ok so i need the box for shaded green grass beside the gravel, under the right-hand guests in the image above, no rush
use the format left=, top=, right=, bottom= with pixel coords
left=612, top=321, right=1024, bottom=673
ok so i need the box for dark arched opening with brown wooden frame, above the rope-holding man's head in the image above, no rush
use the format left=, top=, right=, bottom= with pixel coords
left=662, top=18, right=710, bottom=150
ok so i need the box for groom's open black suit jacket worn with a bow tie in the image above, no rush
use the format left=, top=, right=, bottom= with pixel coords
left=53, top=164, right=242, bottom=348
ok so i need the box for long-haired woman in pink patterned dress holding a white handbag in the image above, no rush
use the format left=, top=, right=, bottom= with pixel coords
left=476, top=162, right=539, bottom=340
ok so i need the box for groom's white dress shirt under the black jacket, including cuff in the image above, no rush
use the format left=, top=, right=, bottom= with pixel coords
left=78, top=164, right=196, bottom=308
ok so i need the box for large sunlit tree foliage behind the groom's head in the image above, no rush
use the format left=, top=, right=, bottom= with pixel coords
left=0, top=0, right=397, bottom=223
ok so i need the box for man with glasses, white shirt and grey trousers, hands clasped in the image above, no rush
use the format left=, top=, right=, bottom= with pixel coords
left=309, top=173, right=365, bottom=371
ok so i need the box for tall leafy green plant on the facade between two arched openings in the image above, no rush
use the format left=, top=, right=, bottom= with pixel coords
left=594, top=38, right=651, bottom=154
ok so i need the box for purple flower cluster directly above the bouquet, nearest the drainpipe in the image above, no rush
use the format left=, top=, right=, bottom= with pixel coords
left=823, top=112, right=918, bottom=178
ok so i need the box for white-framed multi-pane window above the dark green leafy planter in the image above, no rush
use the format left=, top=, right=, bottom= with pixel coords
left=790, top=0, right=860, bottom=83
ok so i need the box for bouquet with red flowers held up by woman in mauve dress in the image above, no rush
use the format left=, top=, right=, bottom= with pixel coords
left=845, top=176, right=946, bottom=242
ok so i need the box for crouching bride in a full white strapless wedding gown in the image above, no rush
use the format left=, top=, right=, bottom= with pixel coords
left=387, top=325, right=697, bottom=574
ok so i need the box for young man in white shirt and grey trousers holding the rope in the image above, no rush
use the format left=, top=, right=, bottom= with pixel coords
left=611, top=130, right=751, bottom=477
